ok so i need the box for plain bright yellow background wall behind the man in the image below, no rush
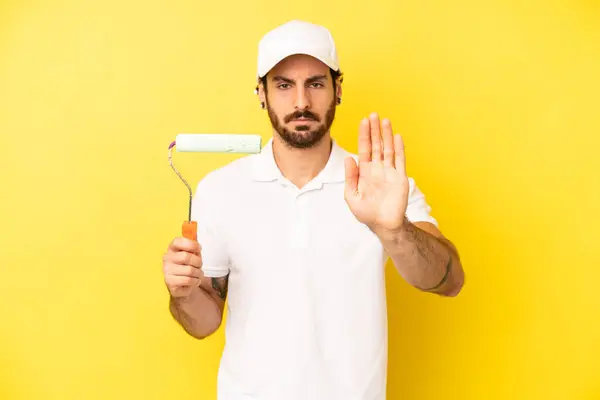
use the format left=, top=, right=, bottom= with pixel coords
left=0, top=0, right=600, bottom=400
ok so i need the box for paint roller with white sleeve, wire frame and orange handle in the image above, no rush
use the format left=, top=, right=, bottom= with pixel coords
left=169, top=133, right=262, bottom=240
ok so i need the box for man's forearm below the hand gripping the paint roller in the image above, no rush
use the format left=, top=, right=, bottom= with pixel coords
left=169, top=287, right=222, bottom=339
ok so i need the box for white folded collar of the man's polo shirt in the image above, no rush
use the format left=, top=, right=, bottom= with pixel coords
left=253, top=138, right=350, bottom=183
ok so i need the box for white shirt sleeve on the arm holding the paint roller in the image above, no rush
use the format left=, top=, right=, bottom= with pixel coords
left=192, top=175, right=230, bottom=278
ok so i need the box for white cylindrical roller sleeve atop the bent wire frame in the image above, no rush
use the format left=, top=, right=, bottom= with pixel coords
left=175, top=133, right=262, bottom=153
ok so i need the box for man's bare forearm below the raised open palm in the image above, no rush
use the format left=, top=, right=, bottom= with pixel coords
left=376, top=219, right=464, bottom=296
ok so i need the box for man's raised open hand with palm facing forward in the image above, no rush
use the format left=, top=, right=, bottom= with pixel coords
left=344, top=114, right=409, bottom=231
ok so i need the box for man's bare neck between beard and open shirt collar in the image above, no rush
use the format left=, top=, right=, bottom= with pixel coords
left=273, top=132, right=332, bottom=189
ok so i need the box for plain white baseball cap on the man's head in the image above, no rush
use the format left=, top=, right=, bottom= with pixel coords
left=258, top=20, right=340, bottom=78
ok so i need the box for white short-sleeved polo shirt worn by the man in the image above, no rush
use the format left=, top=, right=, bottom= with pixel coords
left=192, top=139, right=437, bottom=400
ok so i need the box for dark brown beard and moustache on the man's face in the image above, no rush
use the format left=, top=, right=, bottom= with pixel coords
left=267, top=98, right=336, bottom=149
